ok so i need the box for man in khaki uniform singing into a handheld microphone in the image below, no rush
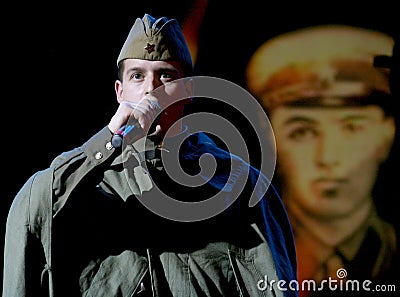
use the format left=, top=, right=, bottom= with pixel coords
left=3, top=14, right=297, bottom=297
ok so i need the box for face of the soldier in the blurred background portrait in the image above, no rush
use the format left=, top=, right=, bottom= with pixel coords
left=271, top=106, right=394, bottom=218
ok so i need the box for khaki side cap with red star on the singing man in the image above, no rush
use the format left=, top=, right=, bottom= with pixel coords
left=117, top=14, right=193, bottom=75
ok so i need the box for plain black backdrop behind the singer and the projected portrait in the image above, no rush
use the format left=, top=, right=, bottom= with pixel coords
left=0, top=0, right=400, bottom=292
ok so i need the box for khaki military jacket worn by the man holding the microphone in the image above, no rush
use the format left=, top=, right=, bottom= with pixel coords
left=3, top=127, right=297, bottom=297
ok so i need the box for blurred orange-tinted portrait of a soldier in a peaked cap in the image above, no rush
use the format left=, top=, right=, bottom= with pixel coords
left=246, top=25, right=400, bottom=296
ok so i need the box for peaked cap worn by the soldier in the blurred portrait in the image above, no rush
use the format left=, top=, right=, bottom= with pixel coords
left=246, top=24, right=394, bottom=109
